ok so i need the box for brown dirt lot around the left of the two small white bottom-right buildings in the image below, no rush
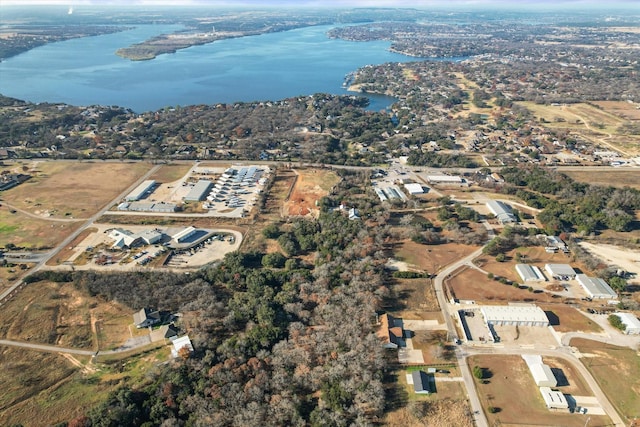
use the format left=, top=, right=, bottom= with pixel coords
left=468, top=355, right=609, bottom=427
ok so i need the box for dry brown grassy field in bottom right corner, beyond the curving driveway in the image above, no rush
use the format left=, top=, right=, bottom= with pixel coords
left=571, top=338, right=640, bottom=422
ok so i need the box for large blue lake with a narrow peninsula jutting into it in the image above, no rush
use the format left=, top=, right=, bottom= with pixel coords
left=0, top=25, right=416, bottom=112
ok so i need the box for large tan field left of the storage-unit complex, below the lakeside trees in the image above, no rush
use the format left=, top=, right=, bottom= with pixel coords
left=3, top=162, right=151, bottom=218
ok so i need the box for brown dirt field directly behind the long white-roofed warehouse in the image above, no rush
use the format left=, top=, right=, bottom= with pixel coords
left=445, top=267, right=554, bottom=303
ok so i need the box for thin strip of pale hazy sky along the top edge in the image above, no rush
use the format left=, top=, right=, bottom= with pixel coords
left=0, top=0, right=640, bottom=6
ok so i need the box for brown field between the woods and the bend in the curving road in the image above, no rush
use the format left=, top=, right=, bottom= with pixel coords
left=395, top=239, right=478, bottom=273
